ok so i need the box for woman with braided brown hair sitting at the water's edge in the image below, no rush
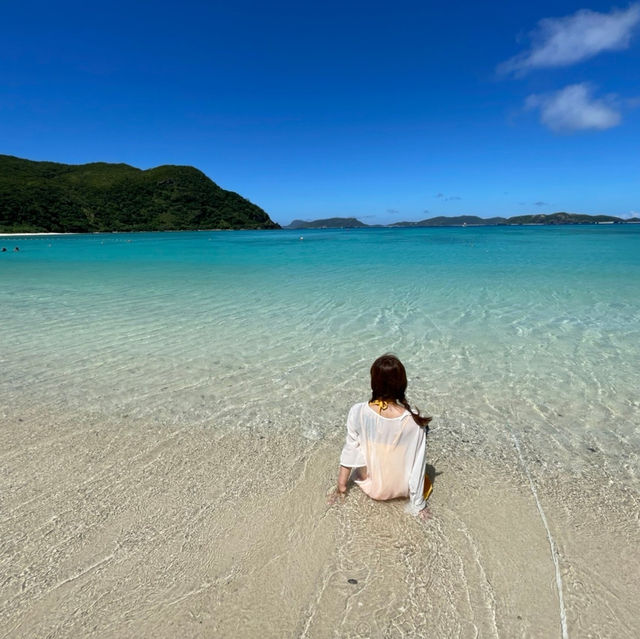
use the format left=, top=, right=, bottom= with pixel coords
left=330, top=354, right=431, bottom=519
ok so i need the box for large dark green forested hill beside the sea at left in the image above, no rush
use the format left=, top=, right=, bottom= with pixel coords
left=0, top=155, right=280, bottom=233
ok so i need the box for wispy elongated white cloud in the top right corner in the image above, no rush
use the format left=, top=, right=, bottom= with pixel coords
left=498, top=3, right=640, bottom=73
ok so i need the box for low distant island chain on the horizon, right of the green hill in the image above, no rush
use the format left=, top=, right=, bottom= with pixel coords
left=283, top=212, right=640, bottom=229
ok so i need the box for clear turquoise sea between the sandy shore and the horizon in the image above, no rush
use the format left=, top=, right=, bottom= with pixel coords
left=0, top=225, right=640, bottom=481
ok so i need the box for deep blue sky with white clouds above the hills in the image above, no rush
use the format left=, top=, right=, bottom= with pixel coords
left=0, top=0, right=640, bottom=224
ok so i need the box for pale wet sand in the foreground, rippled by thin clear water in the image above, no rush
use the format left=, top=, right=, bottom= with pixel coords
left=0, top=405, right=640, bottom=638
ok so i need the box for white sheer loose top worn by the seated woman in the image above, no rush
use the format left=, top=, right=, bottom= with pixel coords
left=340, top=402, right=427, bottom=515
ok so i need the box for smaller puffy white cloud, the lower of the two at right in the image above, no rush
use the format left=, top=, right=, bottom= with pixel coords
left=525, top=82, right=621, bottom=133
